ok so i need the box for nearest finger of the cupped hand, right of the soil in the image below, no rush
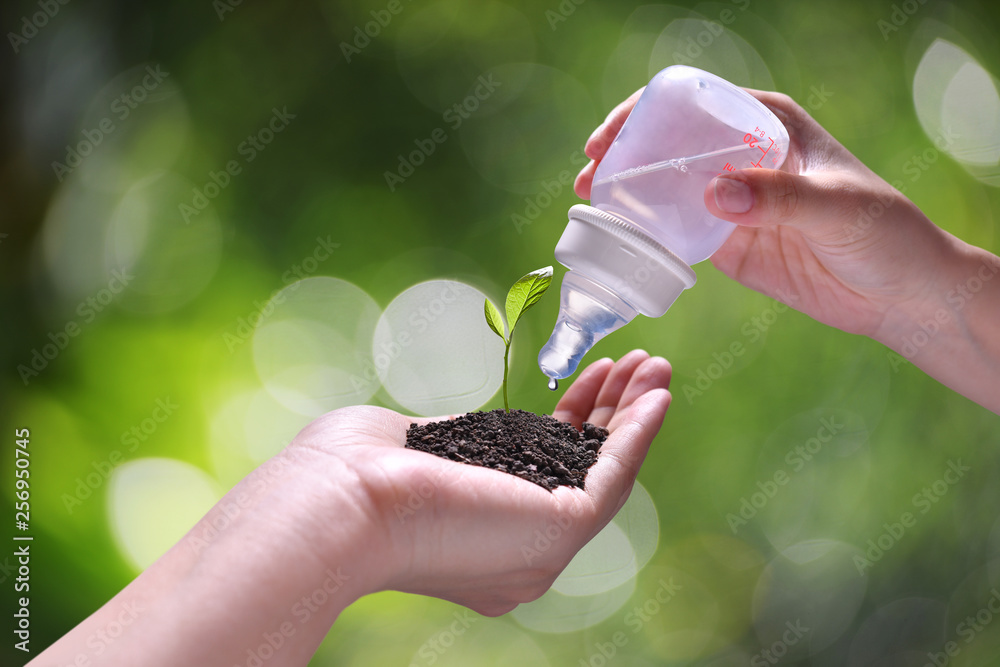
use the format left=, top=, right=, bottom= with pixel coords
left=586, top=389, right=670, bottom=525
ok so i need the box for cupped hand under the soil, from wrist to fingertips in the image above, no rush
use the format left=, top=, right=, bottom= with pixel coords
left=292, top=350, right=670, bottom=615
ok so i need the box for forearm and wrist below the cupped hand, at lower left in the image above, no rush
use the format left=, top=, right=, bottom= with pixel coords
left=35, top=453, right=377, bottom=667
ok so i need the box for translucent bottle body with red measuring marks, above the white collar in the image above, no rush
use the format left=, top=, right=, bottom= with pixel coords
left=591, top=66, right=788, bottom=265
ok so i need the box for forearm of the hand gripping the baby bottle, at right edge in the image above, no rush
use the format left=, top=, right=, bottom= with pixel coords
left=878, top=242, right=1000, bottom=414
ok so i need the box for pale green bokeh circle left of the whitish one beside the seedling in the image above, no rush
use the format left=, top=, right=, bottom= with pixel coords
left=249, top=276, right=379, bottom=417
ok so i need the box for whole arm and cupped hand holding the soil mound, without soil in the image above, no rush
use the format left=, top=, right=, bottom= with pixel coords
left=31, top=351, right=670, bottom=667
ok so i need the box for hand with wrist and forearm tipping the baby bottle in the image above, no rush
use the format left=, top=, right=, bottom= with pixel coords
left=576, top=91, right=1000, bottom=412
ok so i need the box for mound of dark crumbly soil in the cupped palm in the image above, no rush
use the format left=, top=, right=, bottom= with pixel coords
left=406, top=410, right=608, bottom=491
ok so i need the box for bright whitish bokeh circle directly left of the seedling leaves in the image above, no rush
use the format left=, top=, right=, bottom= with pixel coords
left=371, top=280, right=504, bottom=416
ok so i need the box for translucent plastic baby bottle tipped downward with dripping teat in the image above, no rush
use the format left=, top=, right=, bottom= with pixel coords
left=538, top=65, right=788, bottom=386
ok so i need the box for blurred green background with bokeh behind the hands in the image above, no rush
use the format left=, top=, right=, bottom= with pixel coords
left=0, top=0, right=1000, bottom=667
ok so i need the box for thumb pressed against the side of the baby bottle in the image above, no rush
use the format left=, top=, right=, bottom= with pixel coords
left=705, top=169, right=844, bottom=227
